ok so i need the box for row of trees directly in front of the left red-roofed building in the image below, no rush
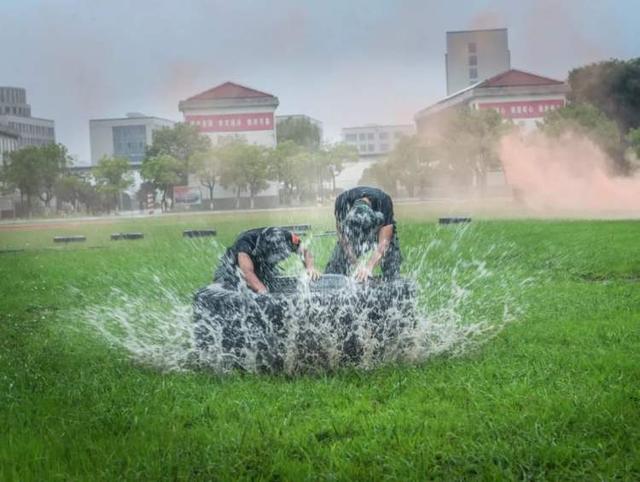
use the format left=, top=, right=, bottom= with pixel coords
left=141, top=119, right=357, bottom=209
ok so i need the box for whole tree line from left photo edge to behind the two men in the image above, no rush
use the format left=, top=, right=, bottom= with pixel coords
left=0, top=119, right=357, bottom=216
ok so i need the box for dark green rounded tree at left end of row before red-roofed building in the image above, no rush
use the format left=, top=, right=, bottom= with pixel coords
left=146, top=122, right=211, bottom=184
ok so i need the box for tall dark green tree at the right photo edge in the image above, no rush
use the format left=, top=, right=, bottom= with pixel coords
left=568, top=58, right=640, bottom=134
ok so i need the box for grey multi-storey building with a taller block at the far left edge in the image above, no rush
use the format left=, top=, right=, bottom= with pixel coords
left=0, top=87, right=56, bottom=147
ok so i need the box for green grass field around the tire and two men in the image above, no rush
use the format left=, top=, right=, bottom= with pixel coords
left=0, top=207, right=640, bottom=481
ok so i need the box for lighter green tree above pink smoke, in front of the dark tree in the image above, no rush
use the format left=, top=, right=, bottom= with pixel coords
left=538, top=104, right=628, bottom=172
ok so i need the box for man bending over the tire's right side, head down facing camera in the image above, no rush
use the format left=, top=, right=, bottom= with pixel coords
left=325, top=186, right=402, bottom=281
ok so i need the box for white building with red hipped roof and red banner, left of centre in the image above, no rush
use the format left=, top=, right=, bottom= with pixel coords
left=178, top=82, right=278, bottom=147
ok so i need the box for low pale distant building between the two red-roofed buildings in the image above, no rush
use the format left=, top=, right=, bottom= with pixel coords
left=342, top=124, right=415, bottom=158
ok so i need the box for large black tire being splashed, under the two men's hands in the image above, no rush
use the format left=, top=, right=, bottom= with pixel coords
left=194, top=275, right=416, bottom=372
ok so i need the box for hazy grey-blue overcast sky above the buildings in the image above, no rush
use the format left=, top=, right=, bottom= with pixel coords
left=0, top=0, right=640, bottom=163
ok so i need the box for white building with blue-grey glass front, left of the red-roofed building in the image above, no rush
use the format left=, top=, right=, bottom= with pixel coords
left=89, top=113, right=174, bottom=167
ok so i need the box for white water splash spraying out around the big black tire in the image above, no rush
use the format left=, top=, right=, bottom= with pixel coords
left=71, top=227, right=532, bottom=373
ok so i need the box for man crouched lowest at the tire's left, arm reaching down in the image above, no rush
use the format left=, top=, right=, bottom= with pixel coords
left=213, top=228, right=319, bottom=294
